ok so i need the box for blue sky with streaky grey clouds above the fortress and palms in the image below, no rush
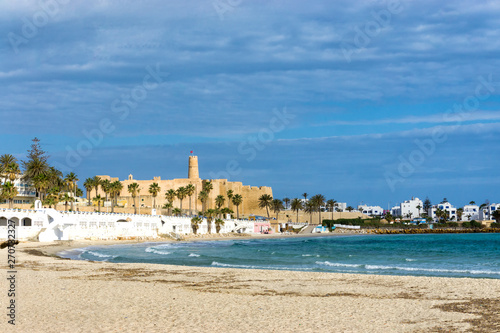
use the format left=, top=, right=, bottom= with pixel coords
left=0, top=0, right=500, bottom=208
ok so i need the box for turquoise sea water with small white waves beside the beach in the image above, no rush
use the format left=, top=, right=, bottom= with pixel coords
left=60, top=234, right=500, bottom=279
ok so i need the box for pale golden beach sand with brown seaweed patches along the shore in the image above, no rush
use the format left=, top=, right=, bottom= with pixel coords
left=0, top=238, right=500, bottom=333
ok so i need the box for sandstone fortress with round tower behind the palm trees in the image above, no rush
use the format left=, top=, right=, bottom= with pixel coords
left=98, top=156, right=273, bottom=217
